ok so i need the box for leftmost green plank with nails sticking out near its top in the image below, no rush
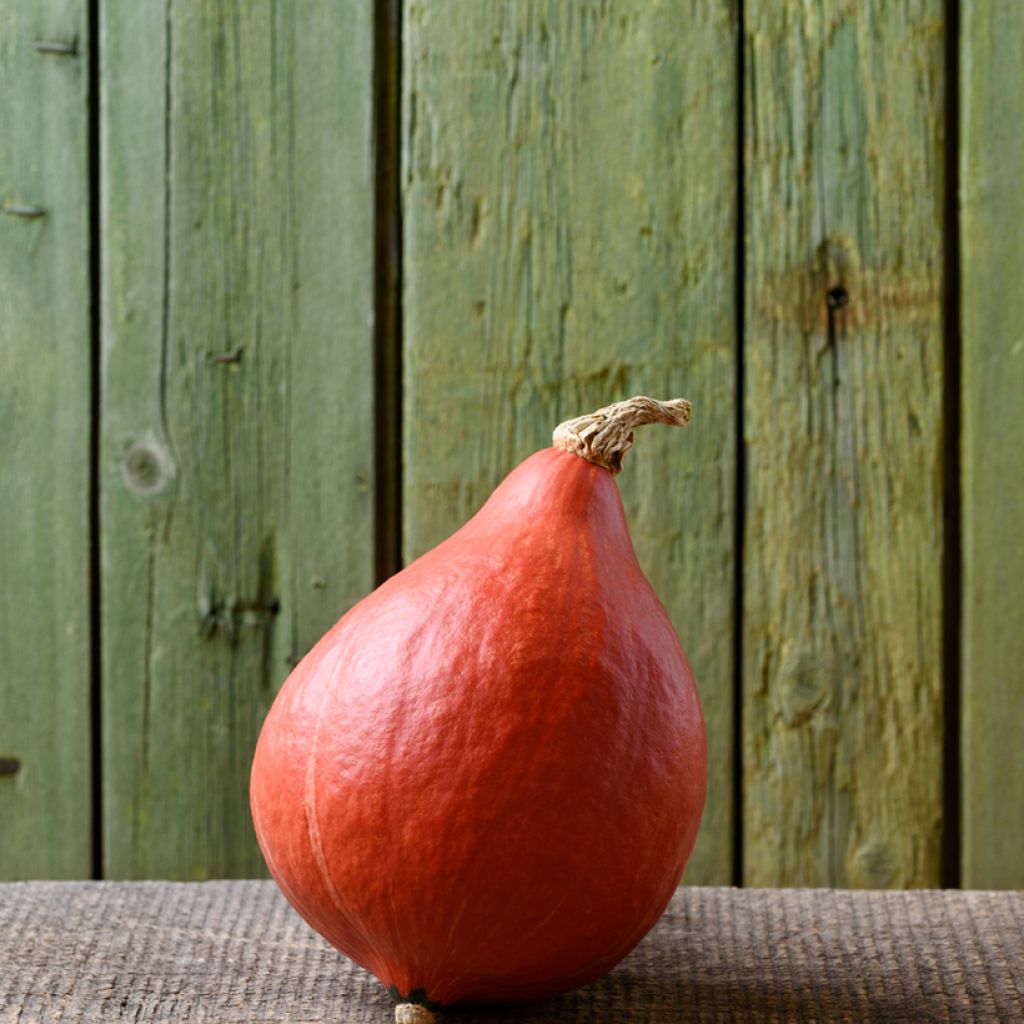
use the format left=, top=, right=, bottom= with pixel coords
left=0, top=0, right=92, bottom=879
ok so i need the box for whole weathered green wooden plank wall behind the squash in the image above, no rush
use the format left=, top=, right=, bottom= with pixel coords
left=0, top=0, right=1024, bottom=887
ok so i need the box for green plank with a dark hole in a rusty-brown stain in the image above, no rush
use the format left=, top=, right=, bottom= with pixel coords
left=743, top=0, right=945, bottom=887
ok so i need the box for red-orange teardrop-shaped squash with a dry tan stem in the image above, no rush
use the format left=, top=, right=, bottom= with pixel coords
left=251, top=397, right=707, bottom=1021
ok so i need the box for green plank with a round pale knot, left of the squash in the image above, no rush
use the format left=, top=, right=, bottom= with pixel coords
left=101, top=0, right=374, bottom=878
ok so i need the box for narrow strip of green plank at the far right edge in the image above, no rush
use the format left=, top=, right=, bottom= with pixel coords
left=959, top=0, right=1024, bottom=889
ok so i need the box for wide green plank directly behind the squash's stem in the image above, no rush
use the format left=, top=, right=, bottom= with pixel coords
left=402, top=0, right=736, bottom=883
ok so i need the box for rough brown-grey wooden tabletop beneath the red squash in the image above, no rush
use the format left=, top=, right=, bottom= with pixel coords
left=0, top=882, right=1024, bottom=1024
